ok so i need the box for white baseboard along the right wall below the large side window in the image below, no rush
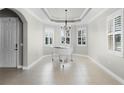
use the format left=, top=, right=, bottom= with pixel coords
left=88, top=56, right=124, bottom=84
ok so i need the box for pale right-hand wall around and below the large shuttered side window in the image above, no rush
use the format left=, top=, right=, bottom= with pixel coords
left=88, top=9, right=124, bottom=79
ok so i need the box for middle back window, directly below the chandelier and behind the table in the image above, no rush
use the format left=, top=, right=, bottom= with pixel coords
left=61, top=29, right=71, bottom=45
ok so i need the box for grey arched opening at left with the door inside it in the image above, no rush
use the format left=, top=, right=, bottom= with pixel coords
left=0, top=8, right=27, bottom=68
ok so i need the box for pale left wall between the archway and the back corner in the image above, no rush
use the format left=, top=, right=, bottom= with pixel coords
left=15, top=8, right=43, bottom=66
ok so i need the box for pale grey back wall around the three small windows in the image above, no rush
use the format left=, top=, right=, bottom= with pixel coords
left=43, top=25, right=88, bottom=55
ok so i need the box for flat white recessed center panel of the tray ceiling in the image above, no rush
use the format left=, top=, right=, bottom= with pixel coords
left=46, top=8, right=85, bottom=20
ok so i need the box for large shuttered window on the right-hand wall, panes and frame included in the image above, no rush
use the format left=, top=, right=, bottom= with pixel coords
left=108, top=9, right=123, bottom=56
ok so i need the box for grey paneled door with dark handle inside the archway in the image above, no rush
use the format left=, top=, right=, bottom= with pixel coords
left=0, top=17, right=18, bottom=68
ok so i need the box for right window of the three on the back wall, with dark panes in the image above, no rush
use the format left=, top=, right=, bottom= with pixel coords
left=77, top=27, right=87, bottom=46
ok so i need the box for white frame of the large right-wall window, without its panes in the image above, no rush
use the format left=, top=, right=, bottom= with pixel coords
left=107, top=9, right=124, bottom=57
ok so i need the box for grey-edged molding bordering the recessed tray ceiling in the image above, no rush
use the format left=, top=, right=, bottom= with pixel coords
left=41, top=8, right=91, bottom=23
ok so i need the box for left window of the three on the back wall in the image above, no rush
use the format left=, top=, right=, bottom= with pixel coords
left=44, top=28, right=53, bottom=46
